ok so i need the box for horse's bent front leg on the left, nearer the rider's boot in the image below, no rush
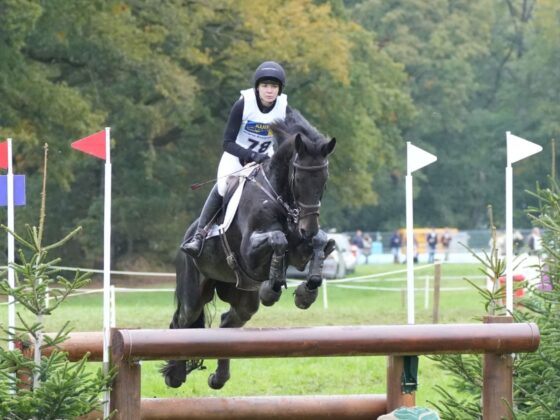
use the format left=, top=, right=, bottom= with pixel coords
left=246, top=230, right=288, bottom=306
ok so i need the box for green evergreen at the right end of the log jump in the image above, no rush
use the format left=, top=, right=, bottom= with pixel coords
left=432, top=185, right=560, bottom=420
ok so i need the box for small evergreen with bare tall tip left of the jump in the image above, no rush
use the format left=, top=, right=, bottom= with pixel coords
left=0, top=145, right=111, bottom=419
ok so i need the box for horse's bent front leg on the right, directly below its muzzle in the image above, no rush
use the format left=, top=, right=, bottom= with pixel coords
left=294, top=230, right=335, bottom=309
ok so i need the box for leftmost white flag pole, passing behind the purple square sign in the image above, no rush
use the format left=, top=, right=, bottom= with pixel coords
left=6, top=138, right=16, bottom=351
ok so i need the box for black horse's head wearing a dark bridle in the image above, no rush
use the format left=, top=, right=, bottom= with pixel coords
left=290, top=134, right=336, bottom=238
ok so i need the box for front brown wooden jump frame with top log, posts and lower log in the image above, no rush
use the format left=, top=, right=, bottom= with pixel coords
left=100, top=317, right=540, bottom=419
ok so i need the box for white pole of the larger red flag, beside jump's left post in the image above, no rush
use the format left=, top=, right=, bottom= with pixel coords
left=103, top=127, right=111, bottom=418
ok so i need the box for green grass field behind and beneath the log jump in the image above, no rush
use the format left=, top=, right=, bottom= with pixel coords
left=0, top=264, right=484, bottom=404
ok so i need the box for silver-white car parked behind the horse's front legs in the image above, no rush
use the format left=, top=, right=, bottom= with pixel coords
left=286, top=233, right=356, bottom=279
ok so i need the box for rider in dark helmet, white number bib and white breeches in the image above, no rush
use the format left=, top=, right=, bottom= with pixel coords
left=181, top=61, right=291, bottom=257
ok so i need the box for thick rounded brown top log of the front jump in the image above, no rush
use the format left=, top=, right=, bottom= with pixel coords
left=112, top=324, right=540, bottom=361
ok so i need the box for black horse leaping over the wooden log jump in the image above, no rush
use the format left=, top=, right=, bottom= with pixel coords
left=162, top=111, right=336, bottom=389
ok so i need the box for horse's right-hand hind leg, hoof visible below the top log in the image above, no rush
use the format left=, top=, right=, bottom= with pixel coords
left=208, top=283, right=259, bottom=389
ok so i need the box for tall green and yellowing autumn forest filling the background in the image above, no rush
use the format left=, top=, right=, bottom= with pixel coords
left=0, top=0, right=560, bottom=266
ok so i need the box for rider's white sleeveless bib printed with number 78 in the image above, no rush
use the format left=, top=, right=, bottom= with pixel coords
left=235, top=89, right=288, bottom=155
